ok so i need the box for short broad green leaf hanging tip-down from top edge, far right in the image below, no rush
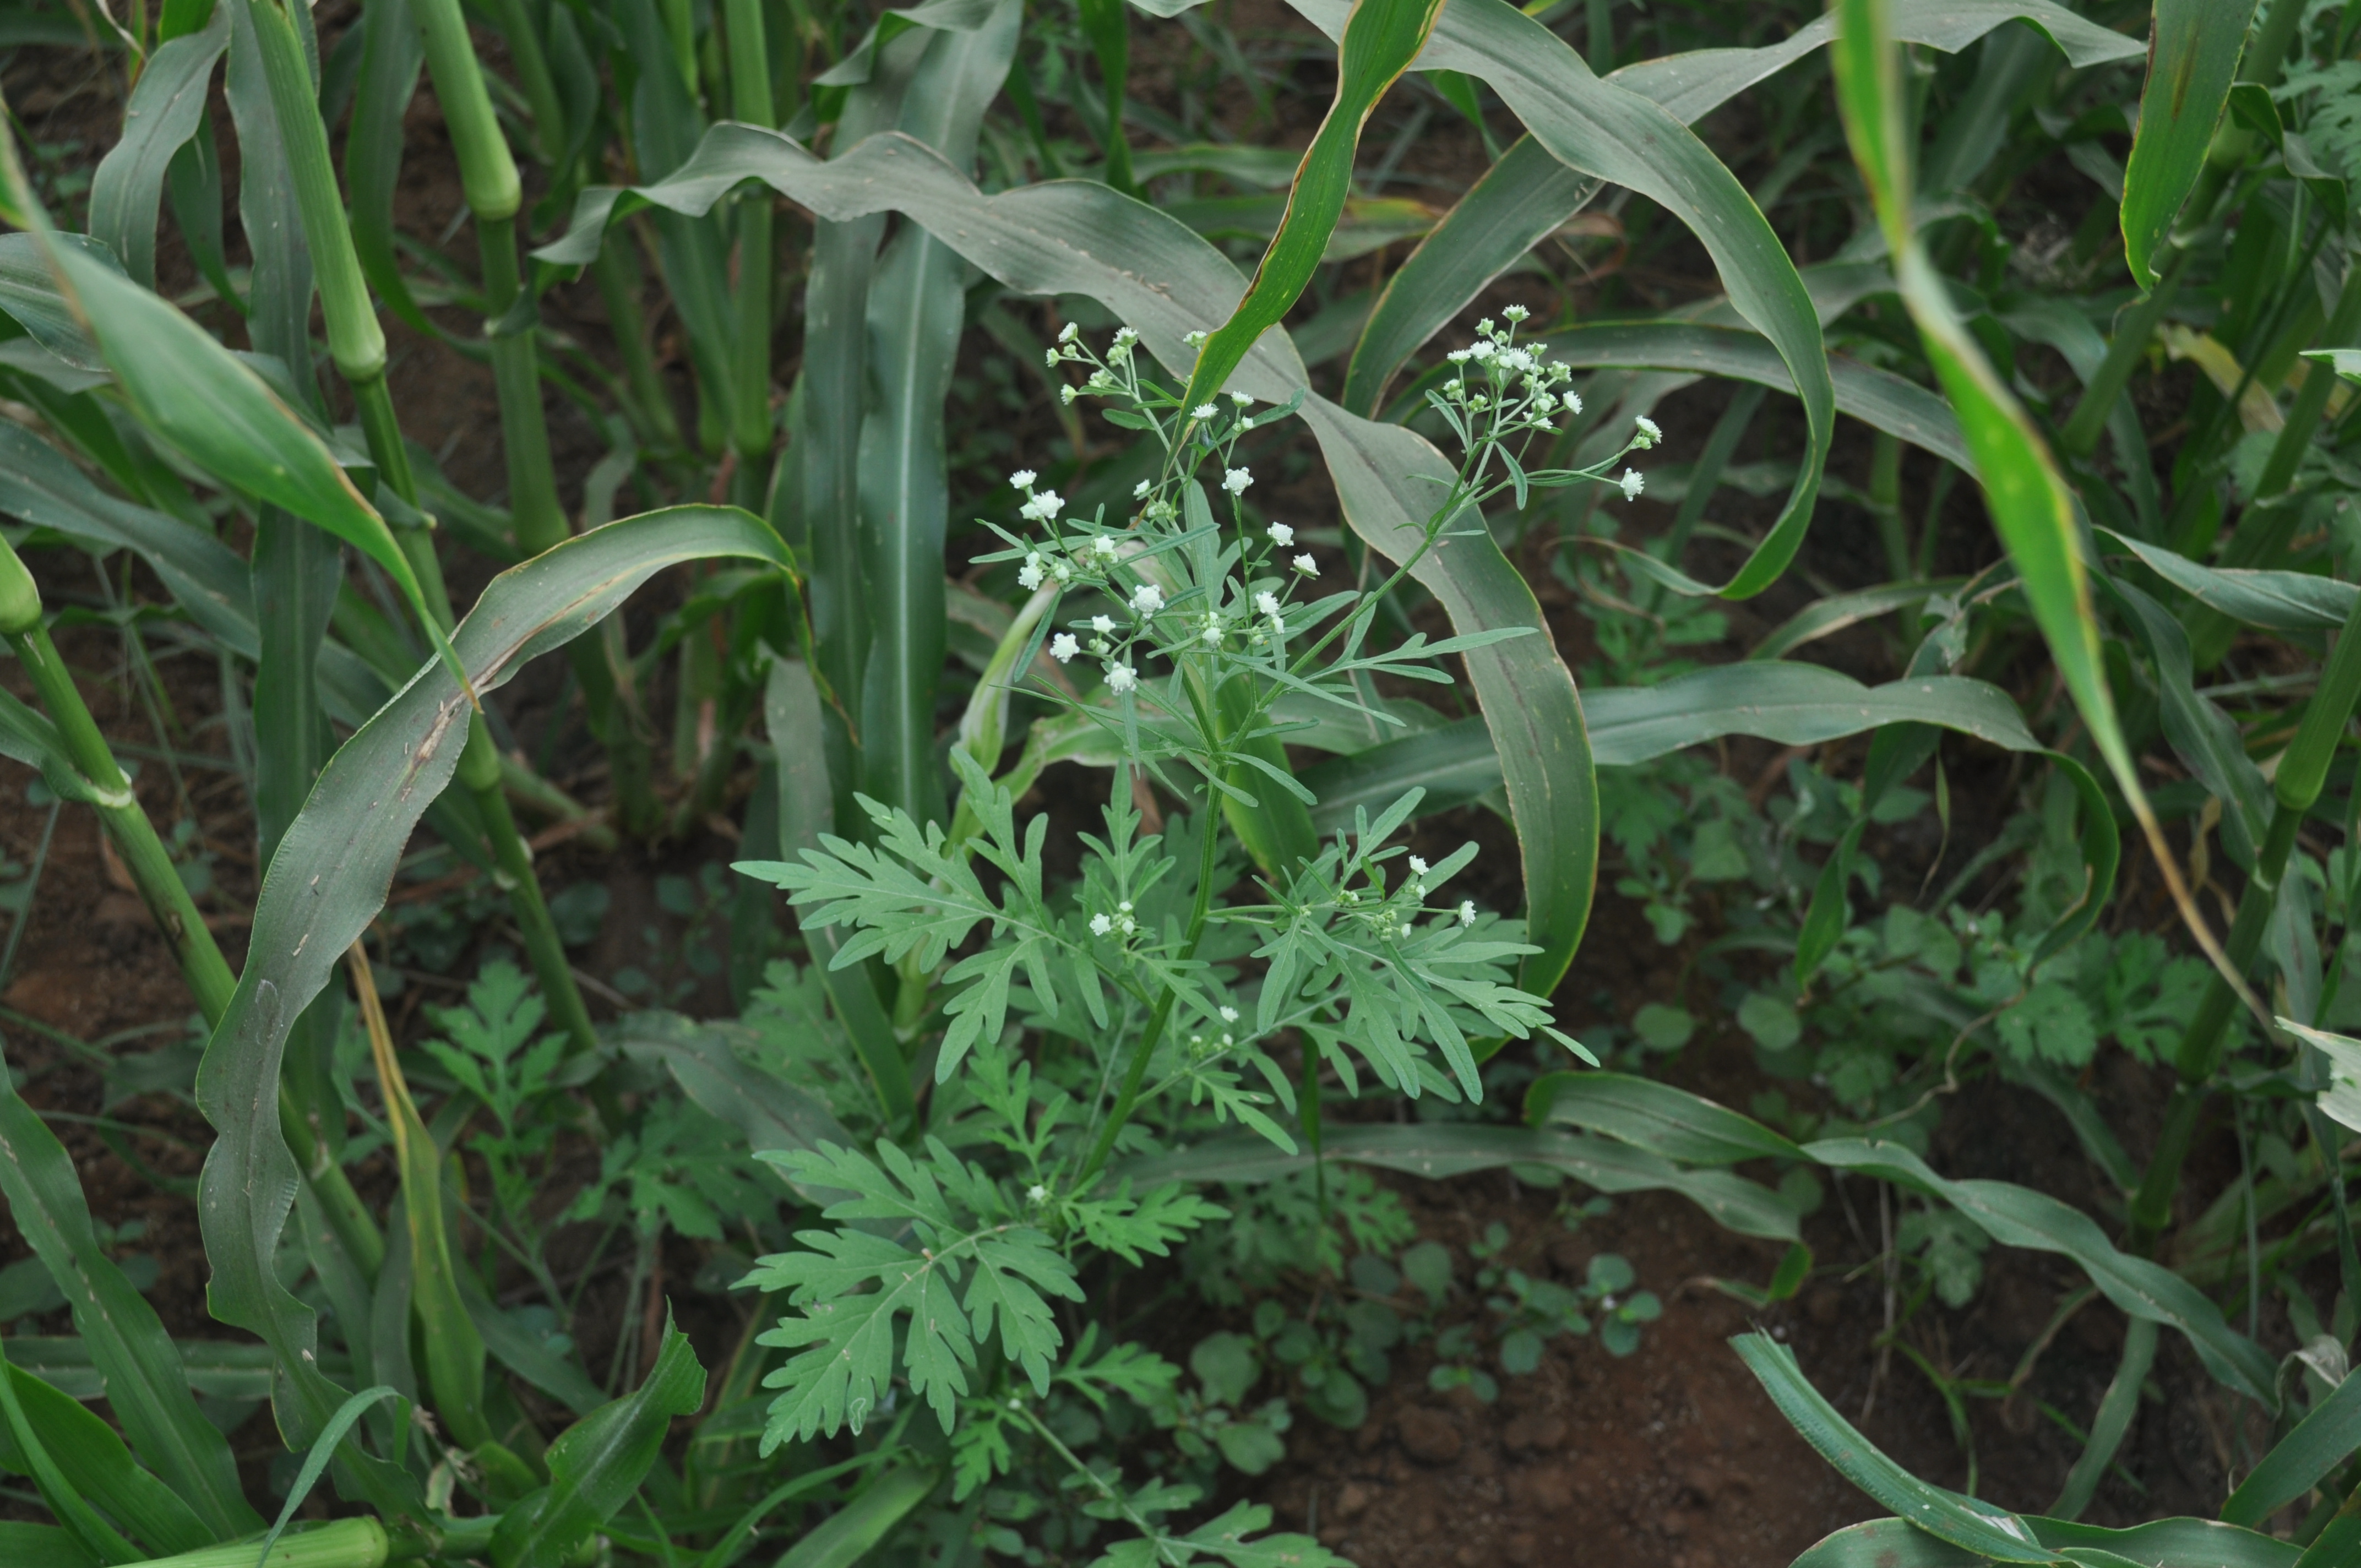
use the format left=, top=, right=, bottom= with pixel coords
left=2123, top=0, right=2255, bottom=288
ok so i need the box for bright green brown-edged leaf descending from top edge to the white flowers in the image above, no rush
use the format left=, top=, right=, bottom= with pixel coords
left=1180, top=0, right=1445, bottom=409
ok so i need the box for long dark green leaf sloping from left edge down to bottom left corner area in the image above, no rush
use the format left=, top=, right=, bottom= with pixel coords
left=0, top=1048, right=262, bottom=1549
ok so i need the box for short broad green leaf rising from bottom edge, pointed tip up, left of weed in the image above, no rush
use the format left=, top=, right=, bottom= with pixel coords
left=491, top=1322, right=706, bottom=1568
